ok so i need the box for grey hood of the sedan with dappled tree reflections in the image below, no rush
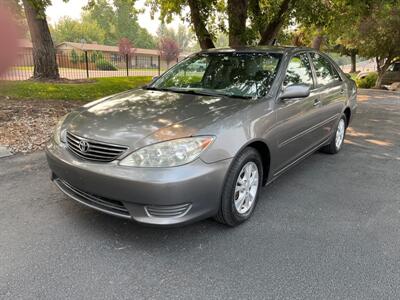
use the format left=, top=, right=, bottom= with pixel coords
left=66, top=89, right=251, bottom=147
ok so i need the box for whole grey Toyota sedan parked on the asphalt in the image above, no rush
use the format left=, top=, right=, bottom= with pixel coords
left=47, top=47, right=356, bottom=226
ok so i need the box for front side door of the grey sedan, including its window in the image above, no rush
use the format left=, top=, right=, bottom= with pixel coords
left=273, top=52, right=320, bottom=175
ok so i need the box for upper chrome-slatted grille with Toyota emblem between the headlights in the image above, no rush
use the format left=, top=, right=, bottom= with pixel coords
left=67, top=132, right=128, bottom=162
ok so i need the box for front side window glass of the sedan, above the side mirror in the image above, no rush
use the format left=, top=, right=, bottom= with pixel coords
left=283, top=53, right=314, bottom=87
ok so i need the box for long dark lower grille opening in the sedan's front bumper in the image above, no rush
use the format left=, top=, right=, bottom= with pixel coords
left=54, top=178, right=131, bottom=218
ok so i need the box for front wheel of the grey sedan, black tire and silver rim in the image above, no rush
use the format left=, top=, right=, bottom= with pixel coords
left=215, top=148, right=263, bottom=226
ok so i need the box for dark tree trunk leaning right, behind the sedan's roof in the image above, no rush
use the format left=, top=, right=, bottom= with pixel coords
left=258, top=0, right=296, bottom=45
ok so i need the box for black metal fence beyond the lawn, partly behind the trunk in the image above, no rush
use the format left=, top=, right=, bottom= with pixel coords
left=0, top=50, right=178, bottom=80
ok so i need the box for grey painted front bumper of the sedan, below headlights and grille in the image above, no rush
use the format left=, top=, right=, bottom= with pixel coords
left=46, top=143, right=231, bottom=225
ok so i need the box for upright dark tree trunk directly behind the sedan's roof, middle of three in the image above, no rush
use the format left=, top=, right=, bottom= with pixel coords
left=228, top=0, right=249, bottom=48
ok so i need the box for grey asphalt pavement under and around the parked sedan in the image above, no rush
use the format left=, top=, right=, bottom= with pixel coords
left=0, top=91, right=400, bottom=299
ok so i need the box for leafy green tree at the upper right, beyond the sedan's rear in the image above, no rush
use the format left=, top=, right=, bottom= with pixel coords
left=299, top=0, right=400, bottom=87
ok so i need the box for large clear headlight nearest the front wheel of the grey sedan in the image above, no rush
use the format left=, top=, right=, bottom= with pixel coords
left=120, top=136, right=214, bottom=168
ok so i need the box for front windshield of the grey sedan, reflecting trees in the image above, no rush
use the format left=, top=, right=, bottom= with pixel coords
left=148, top=53, right=282, bottom=98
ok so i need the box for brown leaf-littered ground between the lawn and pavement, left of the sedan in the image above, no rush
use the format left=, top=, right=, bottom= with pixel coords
left=0, top=99, right=83, bottom=153
